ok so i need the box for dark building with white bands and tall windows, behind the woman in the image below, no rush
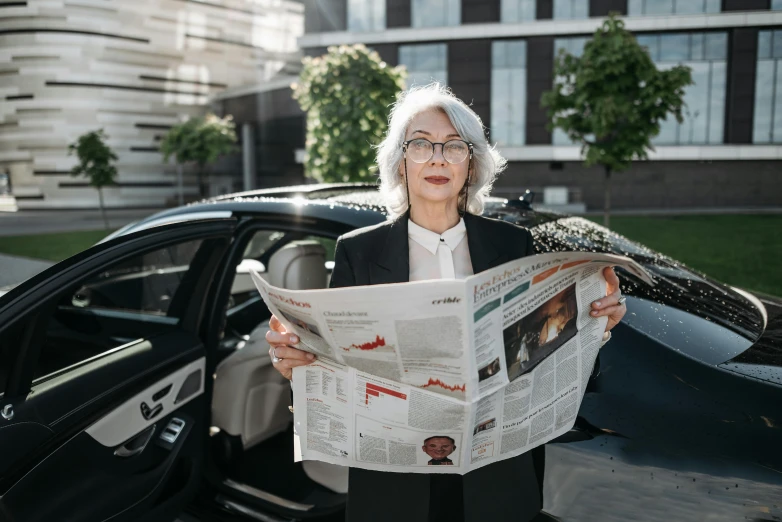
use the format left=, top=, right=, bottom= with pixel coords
left=231, top=0, right=782, bottom=210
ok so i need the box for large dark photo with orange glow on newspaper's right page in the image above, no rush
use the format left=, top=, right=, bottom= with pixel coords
left=502, top=283, right=578, bottom=381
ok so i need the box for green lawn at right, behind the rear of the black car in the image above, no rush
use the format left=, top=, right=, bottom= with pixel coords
left=590, top=214, right=782, bottom=296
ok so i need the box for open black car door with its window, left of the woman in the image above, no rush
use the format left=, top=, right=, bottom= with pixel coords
left=0, top=213, right=235, bottom=522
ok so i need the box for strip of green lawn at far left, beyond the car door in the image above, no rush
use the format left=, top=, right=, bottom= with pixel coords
left=0, top=230, right=111, bottom=261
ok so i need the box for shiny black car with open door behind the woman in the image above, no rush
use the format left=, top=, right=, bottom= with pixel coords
left=0, top=184, right=782, bottom=522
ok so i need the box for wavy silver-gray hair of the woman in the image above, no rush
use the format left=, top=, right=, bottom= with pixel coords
left=377, top=83, right=507, bottom=217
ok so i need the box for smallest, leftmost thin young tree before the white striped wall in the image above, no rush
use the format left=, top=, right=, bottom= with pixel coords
left=68, top=129, right=117, bottom=230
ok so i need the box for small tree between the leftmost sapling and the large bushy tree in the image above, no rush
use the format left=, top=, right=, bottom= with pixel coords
left=160, top=114, right=239, bottom=199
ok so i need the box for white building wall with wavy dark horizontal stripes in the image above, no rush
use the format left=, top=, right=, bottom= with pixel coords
left=0, top=0, right=304, bottom=208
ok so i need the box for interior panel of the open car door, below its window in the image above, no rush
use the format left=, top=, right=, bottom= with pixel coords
left=0, top=332, right=206, bottom=521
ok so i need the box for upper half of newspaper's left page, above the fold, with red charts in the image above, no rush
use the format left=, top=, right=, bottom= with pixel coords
left=251, top=273, right=477, bottom=400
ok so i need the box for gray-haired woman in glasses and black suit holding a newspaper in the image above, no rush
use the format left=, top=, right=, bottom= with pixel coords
left=266, top=84, right=625, bottom=522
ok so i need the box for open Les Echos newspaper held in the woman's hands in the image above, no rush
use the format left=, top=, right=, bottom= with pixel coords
left=252, top=252, right=653, bottom=474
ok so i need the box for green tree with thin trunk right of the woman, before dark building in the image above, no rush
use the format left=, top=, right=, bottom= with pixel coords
left=541, top=13, right=692, bottom=226
